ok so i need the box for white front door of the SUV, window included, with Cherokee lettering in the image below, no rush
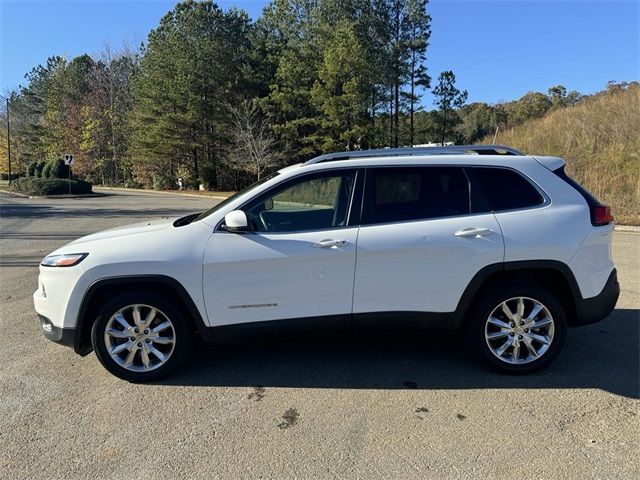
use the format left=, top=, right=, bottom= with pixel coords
left=203, top=169, right=358, bottom=329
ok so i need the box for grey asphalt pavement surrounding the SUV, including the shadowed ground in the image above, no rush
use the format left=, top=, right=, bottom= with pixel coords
left=0, top=192, right=640, bottom=480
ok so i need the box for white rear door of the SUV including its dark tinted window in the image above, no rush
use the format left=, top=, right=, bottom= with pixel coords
left=353, top=166, right=504, bottom=321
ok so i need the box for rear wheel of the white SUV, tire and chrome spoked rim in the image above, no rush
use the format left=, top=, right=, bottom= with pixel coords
left=467, top=283, right=567, bottom=374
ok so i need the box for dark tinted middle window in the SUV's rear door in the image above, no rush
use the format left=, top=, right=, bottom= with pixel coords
left=363, top=167, right=469, bottom=224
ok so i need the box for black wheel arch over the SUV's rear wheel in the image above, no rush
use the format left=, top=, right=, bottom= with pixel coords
left=449, top=260, right=582, bottom=328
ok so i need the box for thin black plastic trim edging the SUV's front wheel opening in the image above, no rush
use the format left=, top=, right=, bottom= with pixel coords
left=73, top=275, right=216, bottom=355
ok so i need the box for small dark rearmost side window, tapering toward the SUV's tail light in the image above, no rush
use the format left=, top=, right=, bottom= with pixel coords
left=472, top=167, right=544, bottom=212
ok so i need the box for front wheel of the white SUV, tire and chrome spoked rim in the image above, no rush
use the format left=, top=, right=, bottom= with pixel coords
left=91, top=292, right=193, bottom=383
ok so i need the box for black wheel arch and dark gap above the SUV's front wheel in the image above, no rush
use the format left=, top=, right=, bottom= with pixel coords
left=73, top=275, right=215, bottom=356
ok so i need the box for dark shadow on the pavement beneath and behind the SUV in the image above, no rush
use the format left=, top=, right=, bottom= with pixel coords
left=158, top=309, right=640, bottom=398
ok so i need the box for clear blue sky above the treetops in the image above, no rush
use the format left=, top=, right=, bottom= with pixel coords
left=0, top=0, right=640, bottom=108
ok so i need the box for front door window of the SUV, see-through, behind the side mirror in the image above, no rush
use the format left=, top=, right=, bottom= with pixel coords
left=243, top=170, right=355, bottom=232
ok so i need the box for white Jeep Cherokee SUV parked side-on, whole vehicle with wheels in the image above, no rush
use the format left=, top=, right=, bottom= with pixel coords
left=33, top=145, right=619, bottom=381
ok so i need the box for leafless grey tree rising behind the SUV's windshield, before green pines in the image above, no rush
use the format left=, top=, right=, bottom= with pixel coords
left=227, top=100, right=280, bottom=180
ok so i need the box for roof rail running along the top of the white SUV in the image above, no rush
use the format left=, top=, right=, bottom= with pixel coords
left=305, top=145, right=524, bottom=165
